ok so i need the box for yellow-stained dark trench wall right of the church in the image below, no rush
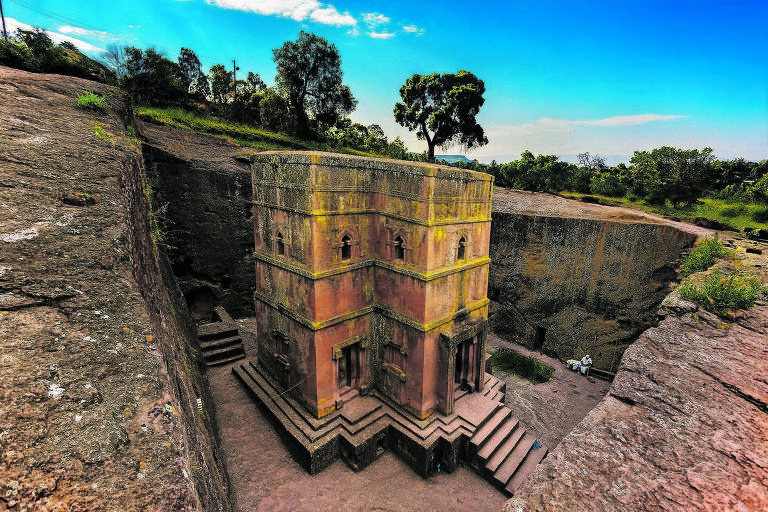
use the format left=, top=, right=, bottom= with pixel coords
left=488, top=212, right=696, bottom=371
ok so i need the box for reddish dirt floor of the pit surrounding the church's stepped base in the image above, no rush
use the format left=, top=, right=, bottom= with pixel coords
left=208, top=322, right=608, bottom=512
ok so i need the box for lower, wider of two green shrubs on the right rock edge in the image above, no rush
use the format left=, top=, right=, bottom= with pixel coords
left=678, top=270, right=763, bottom=315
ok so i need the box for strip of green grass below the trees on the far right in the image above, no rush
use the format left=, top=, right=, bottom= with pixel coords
left=561, top=192, right=768, bottom=231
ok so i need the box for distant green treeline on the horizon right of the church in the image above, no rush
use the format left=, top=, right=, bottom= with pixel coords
left=448, top=146, right=768, bottom=207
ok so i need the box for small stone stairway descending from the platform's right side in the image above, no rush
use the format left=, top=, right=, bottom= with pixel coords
left=469, top=407, right=548, bottom=495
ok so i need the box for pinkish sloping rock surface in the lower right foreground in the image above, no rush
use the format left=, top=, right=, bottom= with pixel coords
left=504, top=288, right=768, bottom=511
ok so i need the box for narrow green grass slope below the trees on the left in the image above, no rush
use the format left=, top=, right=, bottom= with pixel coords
left=135, top=107, right=386, bottom=158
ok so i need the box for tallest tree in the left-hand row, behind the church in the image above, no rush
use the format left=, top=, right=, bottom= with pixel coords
left=272, top=30, right=357, bottom=138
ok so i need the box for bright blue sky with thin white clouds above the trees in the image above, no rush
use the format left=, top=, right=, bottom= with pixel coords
left=2, top=0, right=768, bottom=162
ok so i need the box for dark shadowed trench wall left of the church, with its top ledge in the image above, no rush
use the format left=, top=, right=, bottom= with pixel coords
left=141, top=127, right=256, bottom=320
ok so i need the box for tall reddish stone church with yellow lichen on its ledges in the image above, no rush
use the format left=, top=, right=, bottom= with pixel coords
left=251, top=152, right=493, bottom=419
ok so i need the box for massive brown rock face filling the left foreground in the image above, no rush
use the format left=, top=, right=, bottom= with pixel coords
left=0, top=67, right=230, bottom=512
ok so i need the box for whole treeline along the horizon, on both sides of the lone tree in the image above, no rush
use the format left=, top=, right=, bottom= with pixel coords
left=0, top=28, right=768, bottom=207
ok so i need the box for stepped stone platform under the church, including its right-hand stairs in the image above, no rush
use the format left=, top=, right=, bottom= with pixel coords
left=232, top=360, right=548, bottom=495
